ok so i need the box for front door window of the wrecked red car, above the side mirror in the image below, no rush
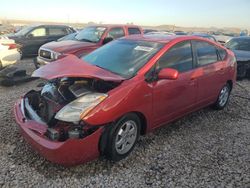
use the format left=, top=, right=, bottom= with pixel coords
left=158, top=41, right=193, bottom=72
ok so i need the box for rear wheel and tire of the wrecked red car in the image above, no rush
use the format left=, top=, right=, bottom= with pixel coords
left=213, top=83, right=232, bottom=110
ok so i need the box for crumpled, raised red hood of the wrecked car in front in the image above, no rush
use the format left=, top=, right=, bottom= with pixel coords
left=32, top=55, right=125, bottom=82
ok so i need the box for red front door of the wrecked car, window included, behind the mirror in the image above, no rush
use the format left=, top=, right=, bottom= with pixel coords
left=153, top=41, right=197, bottom=125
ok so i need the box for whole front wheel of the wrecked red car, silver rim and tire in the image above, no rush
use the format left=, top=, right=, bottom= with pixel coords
left=105, top=113, right=141, bottom=161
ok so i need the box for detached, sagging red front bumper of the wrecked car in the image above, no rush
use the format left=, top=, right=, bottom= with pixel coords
left=14, top=99, right=102, bottom=166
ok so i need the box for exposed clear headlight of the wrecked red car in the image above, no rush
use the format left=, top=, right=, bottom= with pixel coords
left=55, top=93, right=108, bottom=123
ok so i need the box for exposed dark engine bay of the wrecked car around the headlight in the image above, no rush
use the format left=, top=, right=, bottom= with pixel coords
left=24, top=78, right=120, bottom=141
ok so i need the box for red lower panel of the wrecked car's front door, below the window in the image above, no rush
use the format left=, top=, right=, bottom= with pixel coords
left=152, top=71, right=197, bottom=125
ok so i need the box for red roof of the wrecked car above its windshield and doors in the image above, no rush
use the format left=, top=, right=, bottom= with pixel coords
left=122, top=34, right=207, bottom=43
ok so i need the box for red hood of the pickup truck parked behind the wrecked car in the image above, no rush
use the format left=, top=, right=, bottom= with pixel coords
left=41, top=40, right=97, bottom=53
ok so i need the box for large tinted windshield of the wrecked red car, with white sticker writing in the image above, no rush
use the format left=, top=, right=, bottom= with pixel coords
left=82, top=39, right=164, bottom=79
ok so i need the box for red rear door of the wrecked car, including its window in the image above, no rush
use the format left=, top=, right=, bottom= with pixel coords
left=192, top=41, right=226, bottom=105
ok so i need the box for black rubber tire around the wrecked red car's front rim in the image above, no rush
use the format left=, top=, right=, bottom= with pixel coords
left=104, top=113, right=141, bottom=161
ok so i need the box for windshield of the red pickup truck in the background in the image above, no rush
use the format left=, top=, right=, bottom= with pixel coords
left=75, top=27, right=106, bottom=43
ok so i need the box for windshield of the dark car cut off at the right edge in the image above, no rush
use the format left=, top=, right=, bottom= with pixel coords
left=225, top=38, right=250, bottom=51
